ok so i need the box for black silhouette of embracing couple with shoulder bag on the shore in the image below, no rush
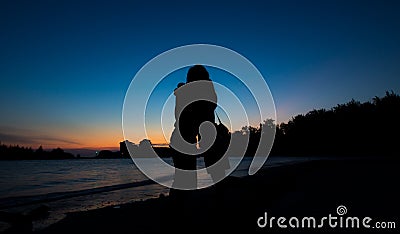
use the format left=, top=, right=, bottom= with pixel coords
left=170, top=65, right=230, bottom=189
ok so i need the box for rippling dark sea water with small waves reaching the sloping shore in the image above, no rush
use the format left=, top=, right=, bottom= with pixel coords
left=0, top=157, right=308, bottom=230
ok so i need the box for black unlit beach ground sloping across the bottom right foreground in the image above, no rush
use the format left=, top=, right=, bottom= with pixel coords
left=10, top=156, right=400, bottom=234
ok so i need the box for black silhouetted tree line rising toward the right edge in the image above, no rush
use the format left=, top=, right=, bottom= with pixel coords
left=248, top=91, right=400, bottom=156
